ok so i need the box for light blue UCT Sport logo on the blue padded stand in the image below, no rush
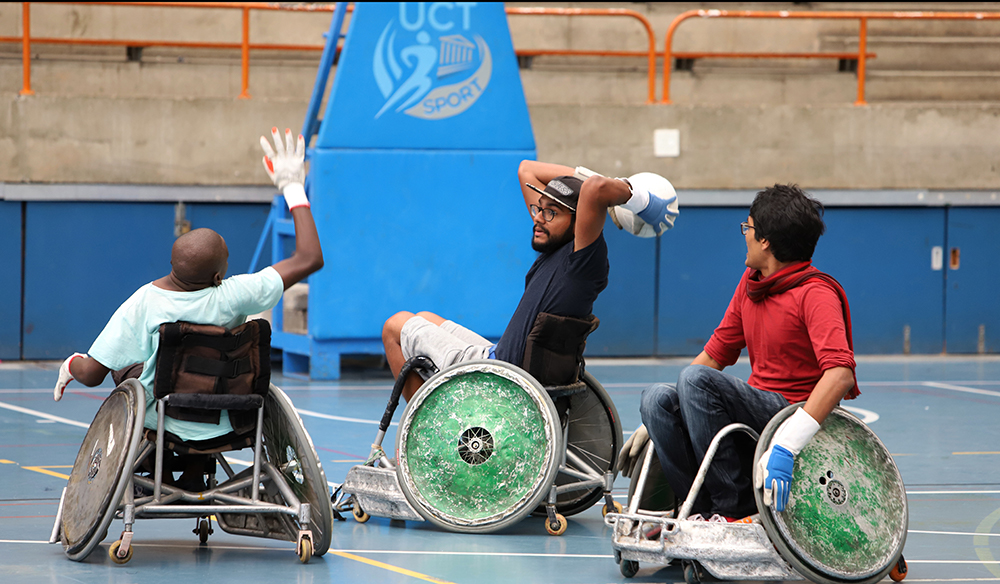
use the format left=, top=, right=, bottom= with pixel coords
left=372, top=2, right=493, bottom=120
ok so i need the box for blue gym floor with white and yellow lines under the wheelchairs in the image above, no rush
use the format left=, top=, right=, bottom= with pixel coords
left=0, top=356, right=1000, bottom=584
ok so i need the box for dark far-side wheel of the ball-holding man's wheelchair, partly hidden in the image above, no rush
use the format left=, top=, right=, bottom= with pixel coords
left=532, top=372, right=622, bottom=517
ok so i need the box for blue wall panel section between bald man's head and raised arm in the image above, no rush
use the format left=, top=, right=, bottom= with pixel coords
left=187, top=203, right=270, bottom=276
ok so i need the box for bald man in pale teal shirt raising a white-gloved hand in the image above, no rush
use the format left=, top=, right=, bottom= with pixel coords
left=54, top=128, right=323, bottom=440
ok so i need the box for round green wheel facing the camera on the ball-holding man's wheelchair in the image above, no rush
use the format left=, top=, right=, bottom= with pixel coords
left=396, top=360, right=562, bottom=533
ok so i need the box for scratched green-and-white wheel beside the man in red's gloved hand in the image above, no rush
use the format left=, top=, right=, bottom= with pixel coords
left=753, top=404, right=908, bottom=584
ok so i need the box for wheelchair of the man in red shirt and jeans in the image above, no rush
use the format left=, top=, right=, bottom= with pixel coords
left=605, top=404, right=908, bottom=584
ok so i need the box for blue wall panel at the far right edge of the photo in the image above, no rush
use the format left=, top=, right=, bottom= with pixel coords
left=945, top=207, right=1000, bottom=353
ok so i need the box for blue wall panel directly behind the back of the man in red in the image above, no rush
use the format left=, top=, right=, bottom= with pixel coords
left=813, top=207, right=945, bottom=354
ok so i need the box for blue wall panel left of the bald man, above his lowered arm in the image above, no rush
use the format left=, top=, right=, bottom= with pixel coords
left=24, top=203, right=174, bottom=359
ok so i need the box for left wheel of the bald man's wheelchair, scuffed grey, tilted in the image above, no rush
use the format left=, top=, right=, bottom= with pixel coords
left=59, top=379, right=146, bottom=562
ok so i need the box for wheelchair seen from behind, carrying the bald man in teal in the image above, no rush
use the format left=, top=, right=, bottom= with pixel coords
left=49, top=320, right=333, bottom=564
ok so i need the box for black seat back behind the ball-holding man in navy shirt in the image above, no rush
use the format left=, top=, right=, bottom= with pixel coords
left=521, top=312, right=601, bottom=394
